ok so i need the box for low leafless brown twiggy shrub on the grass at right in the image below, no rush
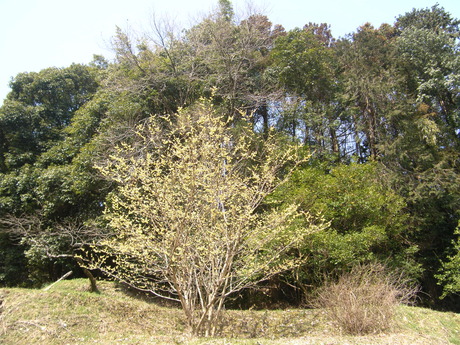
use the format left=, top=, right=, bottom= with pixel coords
left=315, top=264, right=417, bottom=335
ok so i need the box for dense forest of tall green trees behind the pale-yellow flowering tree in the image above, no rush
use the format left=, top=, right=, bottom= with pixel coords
left=0, top=0, right=460, bottom=310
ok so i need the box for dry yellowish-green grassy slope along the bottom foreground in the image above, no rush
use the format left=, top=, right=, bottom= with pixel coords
left=0, top=279, right=460, bottom=345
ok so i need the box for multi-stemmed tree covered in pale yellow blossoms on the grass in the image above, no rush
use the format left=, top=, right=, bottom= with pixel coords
left=93, top=101, right=322, bottom=336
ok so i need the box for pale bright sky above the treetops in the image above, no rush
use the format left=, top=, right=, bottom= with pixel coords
left=0, top=0, right=460, bottom=101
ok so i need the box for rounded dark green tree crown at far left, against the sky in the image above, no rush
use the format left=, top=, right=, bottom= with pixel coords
left=0, top=65, right=98, bottom=171
